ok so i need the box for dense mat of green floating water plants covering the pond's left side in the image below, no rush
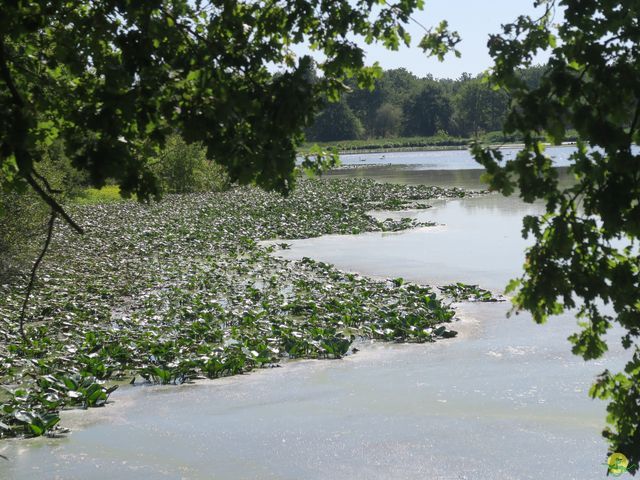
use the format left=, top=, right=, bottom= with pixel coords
left=0, top=180, right=476, bottom=437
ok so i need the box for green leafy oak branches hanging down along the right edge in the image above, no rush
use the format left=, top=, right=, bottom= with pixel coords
left=473, top=0, right=640, bottom=465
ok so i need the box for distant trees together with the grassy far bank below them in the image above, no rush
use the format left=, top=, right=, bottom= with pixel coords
left=299, top=66, right=578, bottom=153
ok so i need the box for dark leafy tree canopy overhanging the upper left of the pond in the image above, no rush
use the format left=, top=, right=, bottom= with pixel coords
left=0, top=0, right=456, bottom=230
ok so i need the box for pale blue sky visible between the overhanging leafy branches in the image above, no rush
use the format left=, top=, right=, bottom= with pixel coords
left=298, top=0, right=557, bottom=79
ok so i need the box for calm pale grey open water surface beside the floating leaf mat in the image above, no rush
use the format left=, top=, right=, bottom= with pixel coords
left=0, top=148, right=623, bottom=480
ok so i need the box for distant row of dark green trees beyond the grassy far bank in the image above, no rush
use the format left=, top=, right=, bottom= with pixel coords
left=307, top=67, right=544, bottom=142
